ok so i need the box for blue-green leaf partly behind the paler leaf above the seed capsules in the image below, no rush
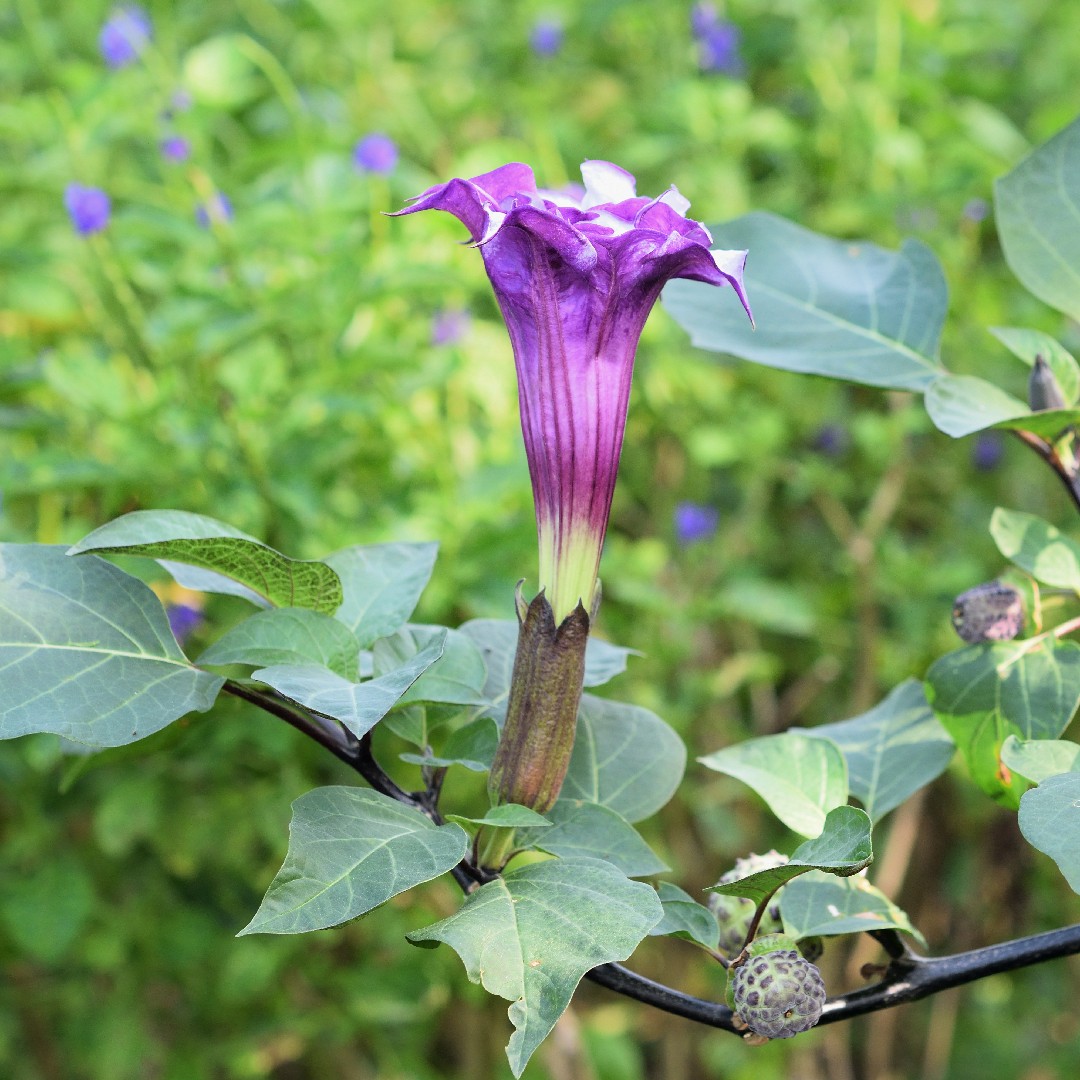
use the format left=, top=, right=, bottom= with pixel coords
left=800, top=679, right=956, bottom=822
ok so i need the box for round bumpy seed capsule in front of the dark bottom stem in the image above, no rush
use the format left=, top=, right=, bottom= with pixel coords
left=729, top=948, right=825, bottom=1039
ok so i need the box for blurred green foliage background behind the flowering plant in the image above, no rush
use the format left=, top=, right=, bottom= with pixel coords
left=6, top=0, right=1080, bottom=1080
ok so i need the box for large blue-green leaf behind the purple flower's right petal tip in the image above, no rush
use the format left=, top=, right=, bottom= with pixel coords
left=663, top=212, right=948, bottom=391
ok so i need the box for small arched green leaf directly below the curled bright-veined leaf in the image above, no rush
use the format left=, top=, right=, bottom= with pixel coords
left=199, top=608, right=360, bottom=679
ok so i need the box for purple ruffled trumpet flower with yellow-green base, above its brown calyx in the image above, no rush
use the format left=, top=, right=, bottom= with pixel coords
left=388, top=161, right=750, bottom=625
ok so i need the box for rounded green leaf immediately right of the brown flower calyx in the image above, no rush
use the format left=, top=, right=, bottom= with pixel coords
left=561, top=693, right=686, bottom=822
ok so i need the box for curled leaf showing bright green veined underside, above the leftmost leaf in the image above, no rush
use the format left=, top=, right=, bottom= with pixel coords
left=68, top=510, right=342, bottom=615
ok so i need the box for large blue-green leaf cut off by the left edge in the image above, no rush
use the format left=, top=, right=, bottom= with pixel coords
left=0, top=544, right=224, bottom=746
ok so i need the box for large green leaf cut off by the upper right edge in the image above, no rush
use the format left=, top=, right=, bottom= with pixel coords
left=994, top=120, right=1080, bottom=319
